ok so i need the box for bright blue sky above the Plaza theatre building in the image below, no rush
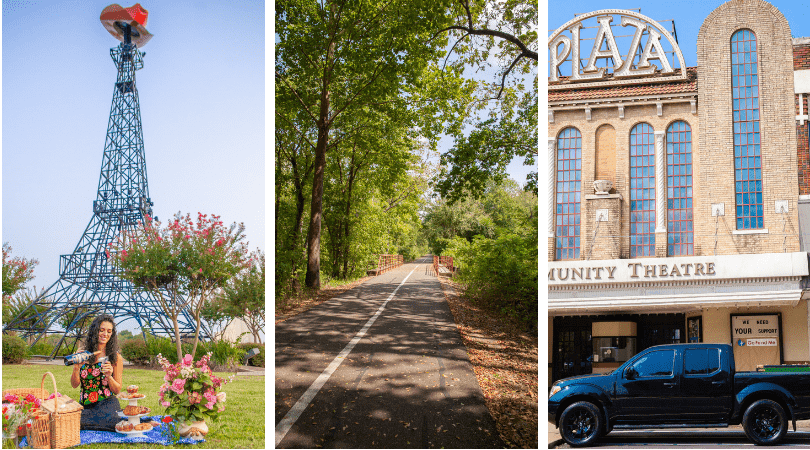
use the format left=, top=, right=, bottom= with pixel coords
left=546, top=0, right=810, bottom=70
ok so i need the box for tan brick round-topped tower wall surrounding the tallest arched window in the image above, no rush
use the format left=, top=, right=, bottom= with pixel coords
left=695, top=0, right=803, bottom=254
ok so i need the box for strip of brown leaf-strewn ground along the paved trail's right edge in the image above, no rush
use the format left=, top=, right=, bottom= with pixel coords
left=440, top=278, right=538, bottom=448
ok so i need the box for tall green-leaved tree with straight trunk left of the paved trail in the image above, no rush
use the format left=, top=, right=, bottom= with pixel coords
left=275, top=0, right=449, bottom=289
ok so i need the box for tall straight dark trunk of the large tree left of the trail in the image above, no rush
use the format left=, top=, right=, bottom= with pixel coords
left=305, top=36, right=335, bottom=289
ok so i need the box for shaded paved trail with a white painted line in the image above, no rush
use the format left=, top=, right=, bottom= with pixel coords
left=275, top=258, right=504, bottom=448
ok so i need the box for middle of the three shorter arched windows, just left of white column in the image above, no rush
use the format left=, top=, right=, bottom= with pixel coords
left=630, top=123, right=655, bottom=258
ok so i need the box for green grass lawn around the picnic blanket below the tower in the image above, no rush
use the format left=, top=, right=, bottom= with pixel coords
left=2, top=364, right=266, bottom=449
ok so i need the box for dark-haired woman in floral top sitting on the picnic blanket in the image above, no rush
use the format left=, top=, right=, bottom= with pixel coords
left=70, top=314, right=146, bottom=431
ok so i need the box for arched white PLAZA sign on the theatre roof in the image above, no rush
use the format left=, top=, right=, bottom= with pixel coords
left=548, top=9, right=686, bottom=82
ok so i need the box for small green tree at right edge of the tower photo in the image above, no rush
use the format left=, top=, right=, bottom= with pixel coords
left=224, top=250, right=265, bottom=342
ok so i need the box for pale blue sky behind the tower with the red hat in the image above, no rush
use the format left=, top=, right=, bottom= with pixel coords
left=2, top=0, right=269, bottom=330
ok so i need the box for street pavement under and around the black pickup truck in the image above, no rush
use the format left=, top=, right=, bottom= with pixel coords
left=548, top=420, right=810, bottom=448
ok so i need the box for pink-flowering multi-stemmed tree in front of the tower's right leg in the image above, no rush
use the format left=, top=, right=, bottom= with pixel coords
left=107, top=213, right=250, bottom=359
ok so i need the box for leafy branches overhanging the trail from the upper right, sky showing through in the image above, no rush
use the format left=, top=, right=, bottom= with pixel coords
left=436, top=0, right=538, bottom=203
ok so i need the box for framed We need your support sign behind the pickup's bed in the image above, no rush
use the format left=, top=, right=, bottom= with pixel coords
left=731, top=314, right=782, bottom=371
